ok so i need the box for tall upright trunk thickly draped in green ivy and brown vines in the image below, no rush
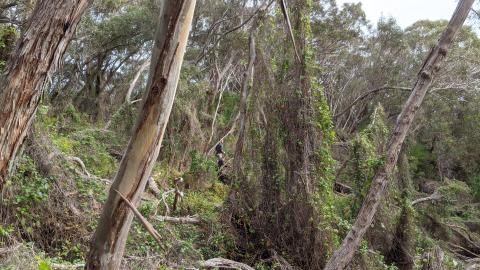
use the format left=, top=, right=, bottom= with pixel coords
left=271, top=0, right=333, bottom=269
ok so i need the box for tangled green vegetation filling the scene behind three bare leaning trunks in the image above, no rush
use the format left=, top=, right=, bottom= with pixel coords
left=0, top=0, right=480, bottom=270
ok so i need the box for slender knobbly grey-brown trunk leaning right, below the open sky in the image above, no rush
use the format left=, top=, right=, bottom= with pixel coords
left=324, top=0, right=474, bottom=270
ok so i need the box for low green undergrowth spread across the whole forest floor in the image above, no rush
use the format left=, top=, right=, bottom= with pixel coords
left=0, top=100, right=480, bottom=270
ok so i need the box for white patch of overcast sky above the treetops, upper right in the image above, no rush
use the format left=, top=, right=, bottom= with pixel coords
left=337, top=0, right=457, bottom=28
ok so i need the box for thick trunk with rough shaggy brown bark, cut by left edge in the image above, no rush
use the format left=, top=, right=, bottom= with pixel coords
left=0, top=0, right=90, bottom=189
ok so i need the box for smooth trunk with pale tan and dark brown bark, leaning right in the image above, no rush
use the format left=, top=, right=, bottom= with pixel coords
left=86, top=0, right=196, bottom=269
